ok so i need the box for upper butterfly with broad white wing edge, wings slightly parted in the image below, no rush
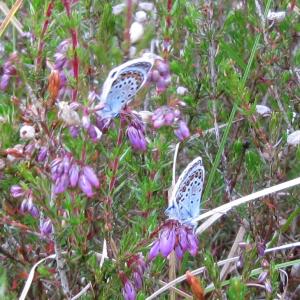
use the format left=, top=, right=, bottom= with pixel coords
left=97, top=53, right=161, bottom=119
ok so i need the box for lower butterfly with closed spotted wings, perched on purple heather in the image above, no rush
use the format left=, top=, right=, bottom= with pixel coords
left=165, top=157, right=205, bottom=226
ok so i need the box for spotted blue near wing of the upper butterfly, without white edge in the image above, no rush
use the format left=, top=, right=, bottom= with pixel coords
left=99, top=62, right=152, bottom=119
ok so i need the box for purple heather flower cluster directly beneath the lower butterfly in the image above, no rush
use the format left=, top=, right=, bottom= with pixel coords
left=148, top=220, right=198, bottom=261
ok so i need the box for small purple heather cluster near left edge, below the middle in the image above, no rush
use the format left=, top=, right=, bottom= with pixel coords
left=10, top=185, right=40, bottom=218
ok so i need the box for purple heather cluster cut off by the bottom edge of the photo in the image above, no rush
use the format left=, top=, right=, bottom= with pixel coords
left=119, top=253, right=146, bottom=300
